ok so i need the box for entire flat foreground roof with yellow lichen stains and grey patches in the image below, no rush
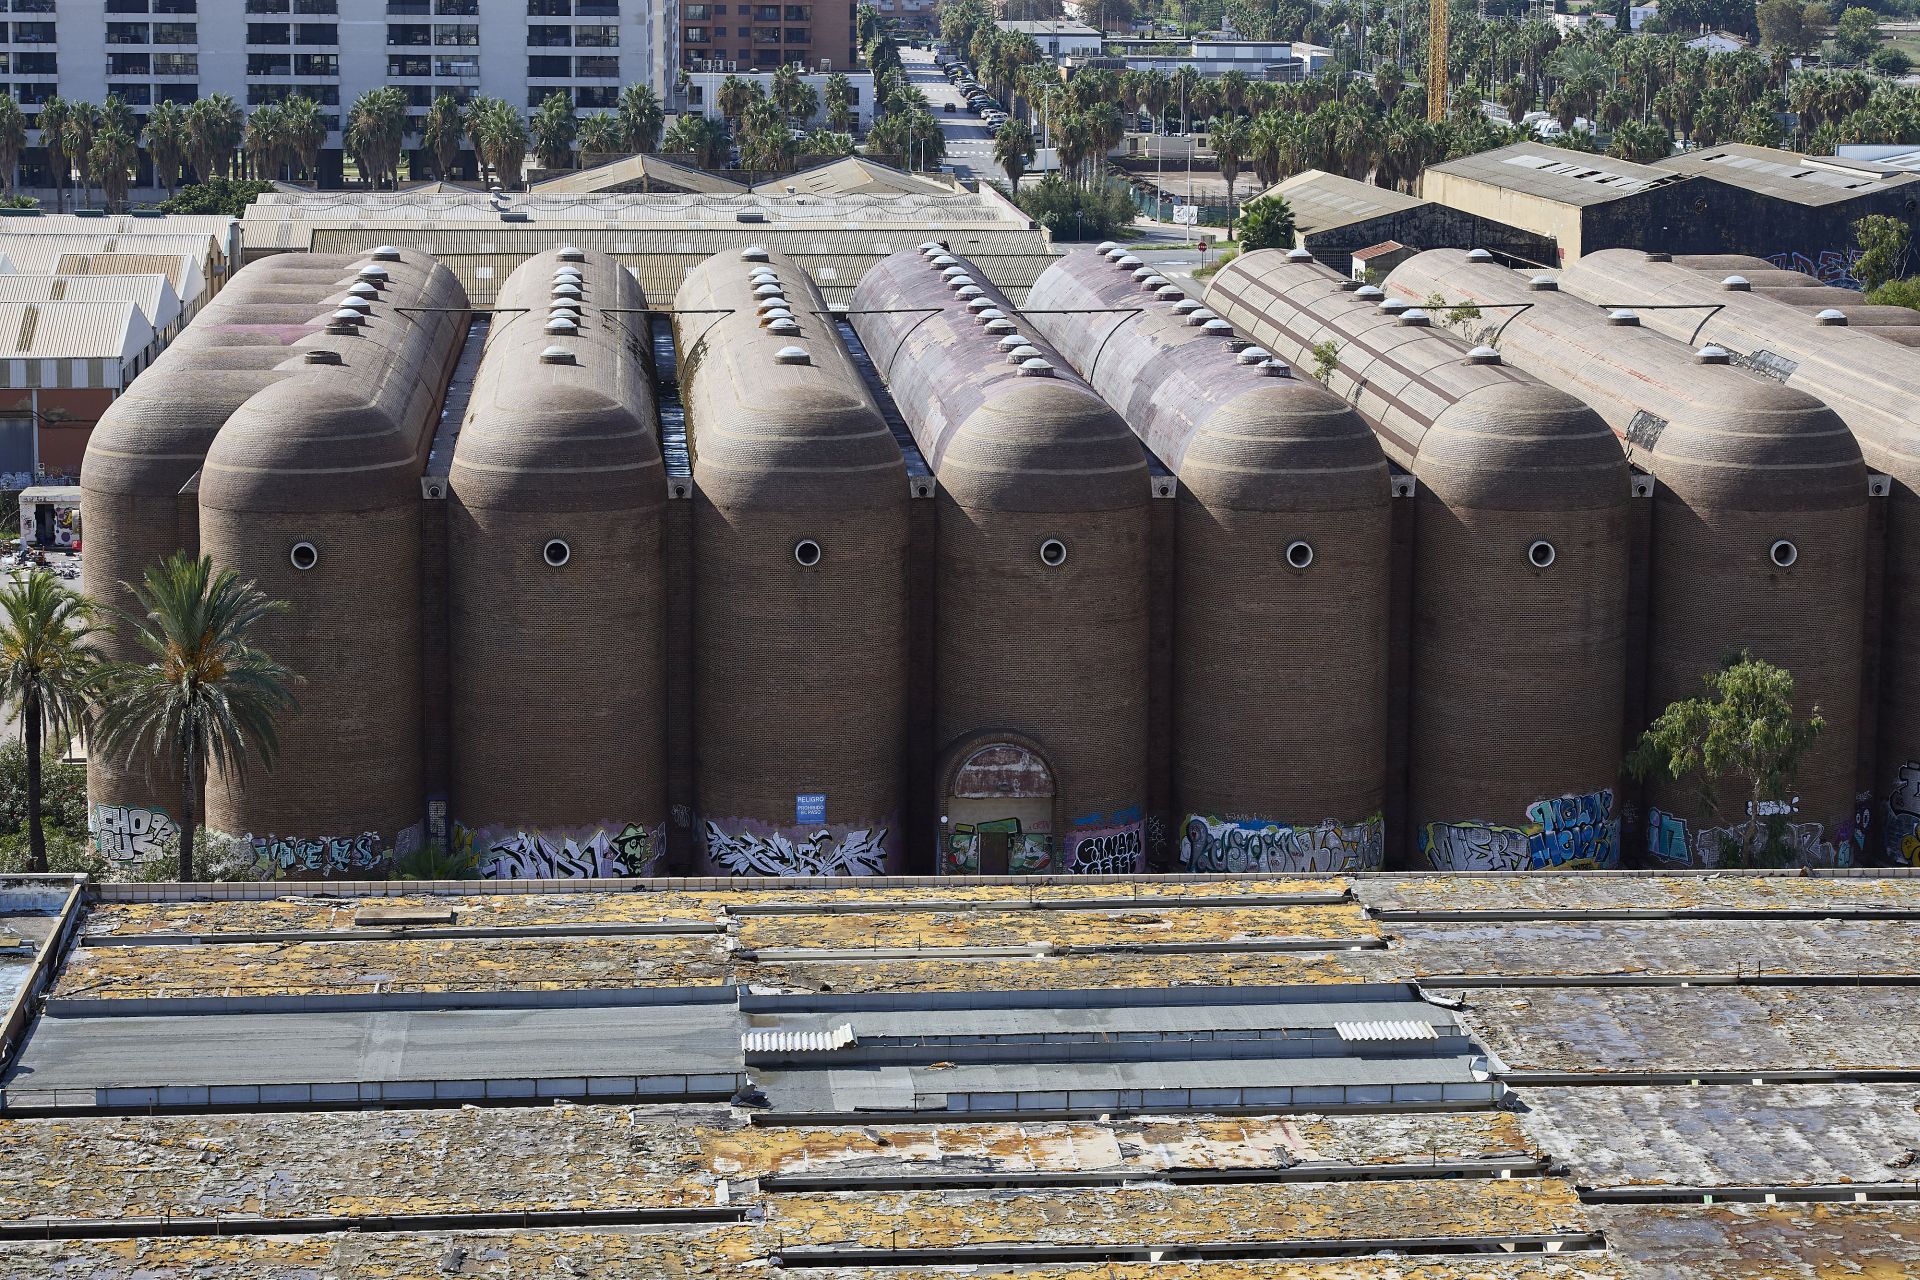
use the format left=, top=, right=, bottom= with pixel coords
left=0, top=871, right=1920, bottom=1280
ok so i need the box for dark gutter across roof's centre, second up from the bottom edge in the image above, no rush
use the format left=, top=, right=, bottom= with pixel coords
left=758, top=1155, right=1551, bottom=1194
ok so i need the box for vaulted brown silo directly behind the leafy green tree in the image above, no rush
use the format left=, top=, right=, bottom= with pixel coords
left=1386, top=249, right=1868, bottom=867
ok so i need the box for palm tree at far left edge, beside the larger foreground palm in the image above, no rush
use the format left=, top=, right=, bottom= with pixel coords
left=0, top=570, right=98, bottom=871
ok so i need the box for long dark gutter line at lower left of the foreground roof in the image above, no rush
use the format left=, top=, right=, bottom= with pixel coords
left=0, top=1209, right=747, bottom=1240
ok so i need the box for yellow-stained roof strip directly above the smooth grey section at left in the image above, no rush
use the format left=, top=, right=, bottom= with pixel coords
left=54, top=935, right=730, bottom=1000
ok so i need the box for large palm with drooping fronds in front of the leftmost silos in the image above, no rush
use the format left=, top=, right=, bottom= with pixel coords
left=94, top=551, right=300, bottom=881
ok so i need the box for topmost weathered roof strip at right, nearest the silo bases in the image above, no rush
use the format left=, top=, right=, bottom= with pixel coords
left=1354, top=871, right=1920, bottom=913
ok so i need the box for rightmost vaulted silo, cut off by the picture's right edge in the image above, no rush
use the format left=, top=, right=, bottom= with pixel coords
left=1561, top=249, right=1920, bottom=864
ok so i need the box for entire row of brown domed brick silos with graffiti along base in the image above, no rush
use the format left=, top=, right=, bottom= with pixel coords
left=83, top=240, right=1920, bottom=877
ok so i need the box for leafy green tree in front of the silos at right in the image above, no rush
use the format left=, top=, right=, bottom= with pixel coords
left=1626, top=651, right=1826, bottom=871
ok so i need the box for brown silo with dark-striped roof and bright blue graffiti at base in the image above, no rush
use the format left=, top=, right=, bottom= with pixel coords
left=1206, top=249, right=1630, bottom=871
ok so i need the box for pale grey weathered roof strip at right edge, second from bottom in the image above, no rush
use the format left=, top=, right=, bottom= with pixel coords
left=1521, top=1084, right=1920, bottom=1188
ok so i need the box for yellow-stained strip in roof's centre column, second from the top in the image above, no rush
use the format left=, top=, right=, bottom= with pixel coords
left=739, top=904, right=1380, bottom=952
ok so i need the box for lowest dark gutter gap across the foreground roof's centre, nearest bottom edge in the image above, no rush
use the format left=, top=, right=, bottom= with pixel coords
left=768, top=1232, right=1607, bottom=1267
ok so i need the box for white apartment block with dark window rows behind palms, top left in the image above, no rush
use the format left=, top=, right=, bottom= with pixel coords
left=0, top=0, right=675, bottom=182
